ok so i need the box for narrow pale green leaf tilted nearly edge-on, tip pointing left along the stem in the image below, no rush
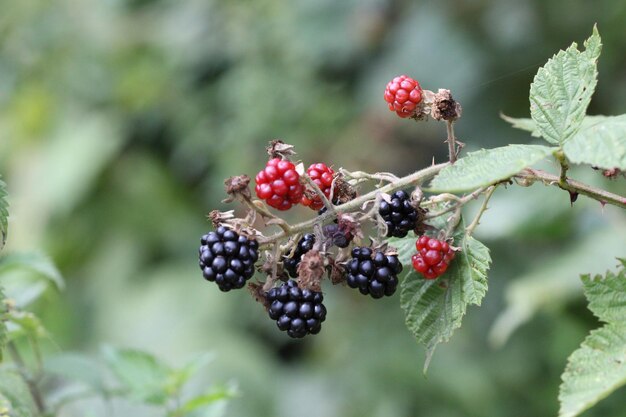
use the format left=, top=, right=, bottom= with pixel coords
left=428, top=145, right=556, bottom=193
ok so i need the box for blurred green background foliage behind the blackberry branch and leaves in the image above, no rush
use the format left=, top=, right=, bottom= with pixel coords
left=0, top=0, right=626, bottom=417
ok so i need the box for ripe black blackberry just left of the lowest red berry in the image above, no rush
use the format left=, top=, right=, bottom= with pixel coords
left=346, top=246, right=402, bottom=298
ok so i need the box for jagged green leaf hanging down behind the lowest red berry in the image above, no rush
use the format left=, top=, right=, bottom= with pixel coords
left=392, top=222, right=491, bottom=372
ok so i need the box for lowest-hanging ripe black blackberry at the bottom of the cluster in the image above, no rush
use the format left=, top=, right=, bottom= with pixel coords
left=265, top=279, right=326, bottom=339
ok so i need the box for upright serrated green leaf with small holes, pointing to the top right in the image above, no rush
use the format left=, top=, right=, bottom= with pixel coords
left=530, top=27, right=602, bottom=145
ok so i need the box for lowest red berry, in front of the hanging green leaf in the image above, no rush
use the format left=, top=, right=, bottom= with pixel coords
left=411, top=236, right=455, bottom=279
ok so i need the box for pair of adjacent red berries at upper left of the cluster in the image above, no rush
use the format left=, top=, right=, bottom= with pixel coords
left=254, top=158, right=335, bottom=211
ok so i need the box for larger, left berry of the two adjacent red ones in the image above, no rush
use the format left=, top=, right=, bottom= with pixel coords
left=254, top=158, right=304, bottom=210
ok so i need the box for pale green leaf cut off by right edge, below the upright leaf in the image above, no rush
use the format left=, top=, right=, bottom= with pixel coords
left=563, top=115, right=626, bottom=170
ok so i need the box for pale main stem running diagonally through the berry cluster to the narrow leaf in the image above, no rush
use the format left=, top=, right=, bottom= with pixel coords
left=259, top=162, right=450, bottom=247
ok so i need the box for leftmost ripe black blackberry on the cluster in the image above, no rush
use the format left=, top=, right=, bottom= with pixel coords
left=198, top=226, right=259, bottom=292
